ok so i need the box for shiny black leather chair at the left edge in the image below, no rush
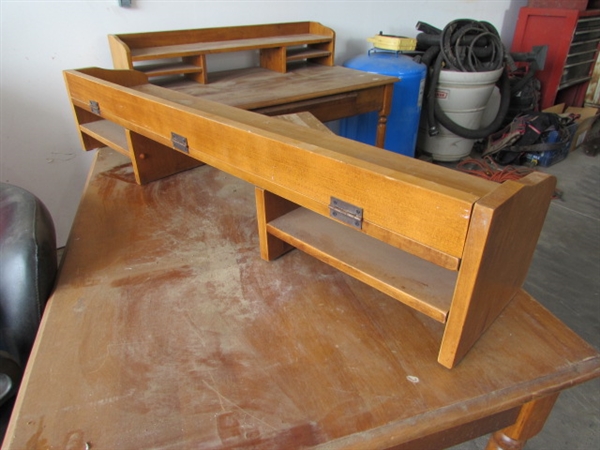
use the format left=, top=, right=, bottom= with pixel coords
left=0, top=183, right=57, bottom=436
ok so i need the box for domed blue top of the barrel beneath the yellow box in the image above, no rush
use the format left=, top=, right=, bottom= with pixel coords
left=343, top=52, right=427, bottom=78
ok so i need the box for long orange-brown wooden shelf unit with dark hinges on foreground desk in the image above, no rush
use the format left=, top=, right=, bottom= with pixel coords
left=65, top=68, right=555, bottom=368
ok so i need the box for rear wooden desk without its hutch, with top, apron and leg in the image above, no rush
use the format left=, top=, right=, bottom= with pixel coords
left=156, top=64, right=398, bottom=139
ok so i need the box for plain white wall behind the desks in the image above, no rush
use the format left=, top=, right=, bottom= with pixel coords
left=0, top=0, right=526, bottom=245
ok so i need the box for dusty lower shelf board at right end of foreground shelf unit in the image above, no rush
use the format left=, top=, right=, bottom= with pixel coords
left=267, top=208, right=457, bottom=323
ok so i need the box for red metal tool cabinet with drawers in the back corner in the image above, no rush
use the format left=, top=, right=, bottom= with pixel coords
left=511, top=8, right=600, bottom=109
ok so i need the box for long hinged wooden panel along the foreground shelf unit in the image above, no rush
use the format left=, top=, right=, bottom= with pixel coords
left=67, top=68, right=476, bottom=263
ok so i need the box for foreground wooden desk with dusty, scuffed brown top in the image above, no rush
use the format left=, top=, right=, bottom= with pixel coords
left=3, top=150, right=600, bottom=450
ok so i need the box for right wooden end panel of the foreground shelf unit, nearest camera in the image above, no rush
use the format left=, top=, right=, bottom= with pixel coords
left=438, top=172, right=556, bottom=368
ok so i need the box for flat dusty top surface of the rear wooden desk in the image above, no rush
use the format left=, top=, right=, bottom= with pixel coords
left=150, top=64, right=398, bottom=110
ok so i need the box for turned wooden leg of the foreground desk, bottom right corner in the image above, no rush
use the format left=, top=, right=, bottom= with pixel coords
left=486, top=392, right=559, bottom=450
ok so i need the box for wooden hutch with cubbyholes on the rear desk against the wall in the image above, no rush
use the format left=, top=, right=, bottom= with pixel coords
left=108, top=22, right=335, bottom=84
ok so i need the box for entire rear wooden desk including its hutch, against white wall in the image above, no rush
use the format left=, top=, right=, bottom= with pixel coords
left=108, top=22, right=398, bottom=152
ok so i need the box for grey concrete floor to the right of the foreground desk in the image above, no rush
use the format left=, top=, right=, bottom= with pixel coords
left=452, top=150, right=600, bottom=450
